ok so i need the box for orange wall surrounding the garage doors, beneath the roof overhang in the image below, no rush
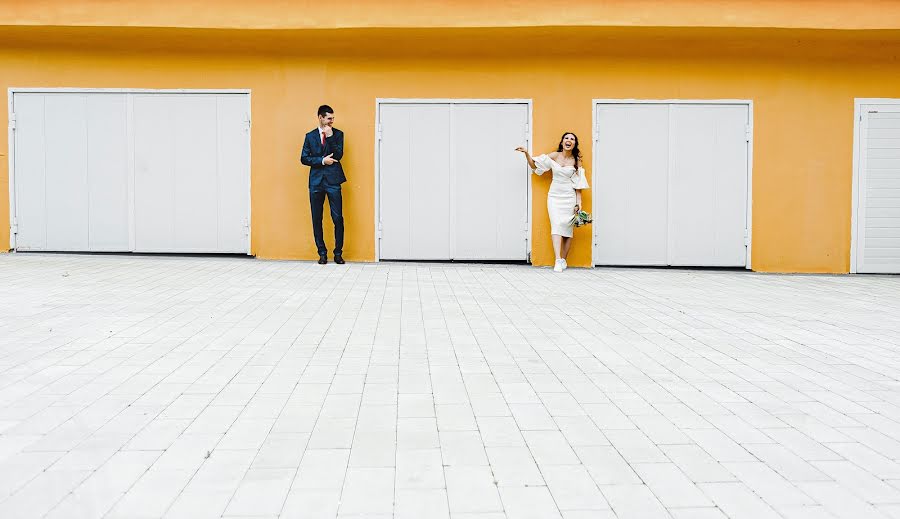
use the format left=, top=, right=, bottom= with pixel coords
left=0, top=34, right=900, bottom=272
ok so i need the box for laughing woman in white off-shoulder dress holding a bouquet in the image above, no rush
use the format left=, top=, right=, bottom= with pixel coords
left=516, top=132, right=589, bottom=272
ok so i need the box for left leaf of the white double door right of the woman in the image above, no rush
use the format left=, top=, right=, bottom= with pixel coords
left=593, top=104, right=669, bottom=265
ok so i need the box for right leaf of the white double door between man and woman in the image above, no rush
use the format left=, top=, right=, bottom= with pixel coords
left=450, top=104, right=530, bottom=260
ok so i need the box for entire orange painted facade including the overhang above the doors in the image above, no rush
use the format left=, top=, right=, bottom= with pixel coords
left=0, top=0, right=900, bottom=273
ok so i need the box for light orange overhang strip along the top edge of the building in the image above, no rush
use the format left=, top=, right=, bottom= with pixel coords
left=7, top=0, right=900, bottom=29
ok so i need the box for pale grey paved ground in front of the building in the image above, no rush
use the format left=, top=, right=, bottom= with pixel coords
left=0, top=254, right=900, bottom=519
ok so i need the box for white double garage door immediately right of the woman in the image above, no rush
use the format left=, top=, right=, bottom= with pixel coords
left=593, top=103, right=750, bottom=267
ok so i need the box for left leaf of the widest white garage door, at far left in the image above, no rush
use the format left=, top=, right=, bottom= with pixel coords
left=13, top=93, right=129, bottom=251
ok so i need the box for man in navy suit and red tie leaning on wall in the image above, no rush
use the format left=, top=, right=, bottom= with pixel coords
left=300, top=105, right=347, bottom=265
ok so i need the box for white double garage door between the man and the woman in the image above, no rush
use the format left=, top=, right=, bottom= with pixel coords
left=379, top=103, right=529, bottom=260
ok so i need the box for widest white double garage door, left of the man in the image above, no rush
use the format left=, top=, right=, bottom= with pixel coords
left=12, top=92, right=250, bottom=254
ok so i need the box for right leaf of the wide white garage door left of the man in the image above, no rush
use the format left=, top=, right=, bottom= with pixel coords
left=133, top=94, right=249, bottom=253
